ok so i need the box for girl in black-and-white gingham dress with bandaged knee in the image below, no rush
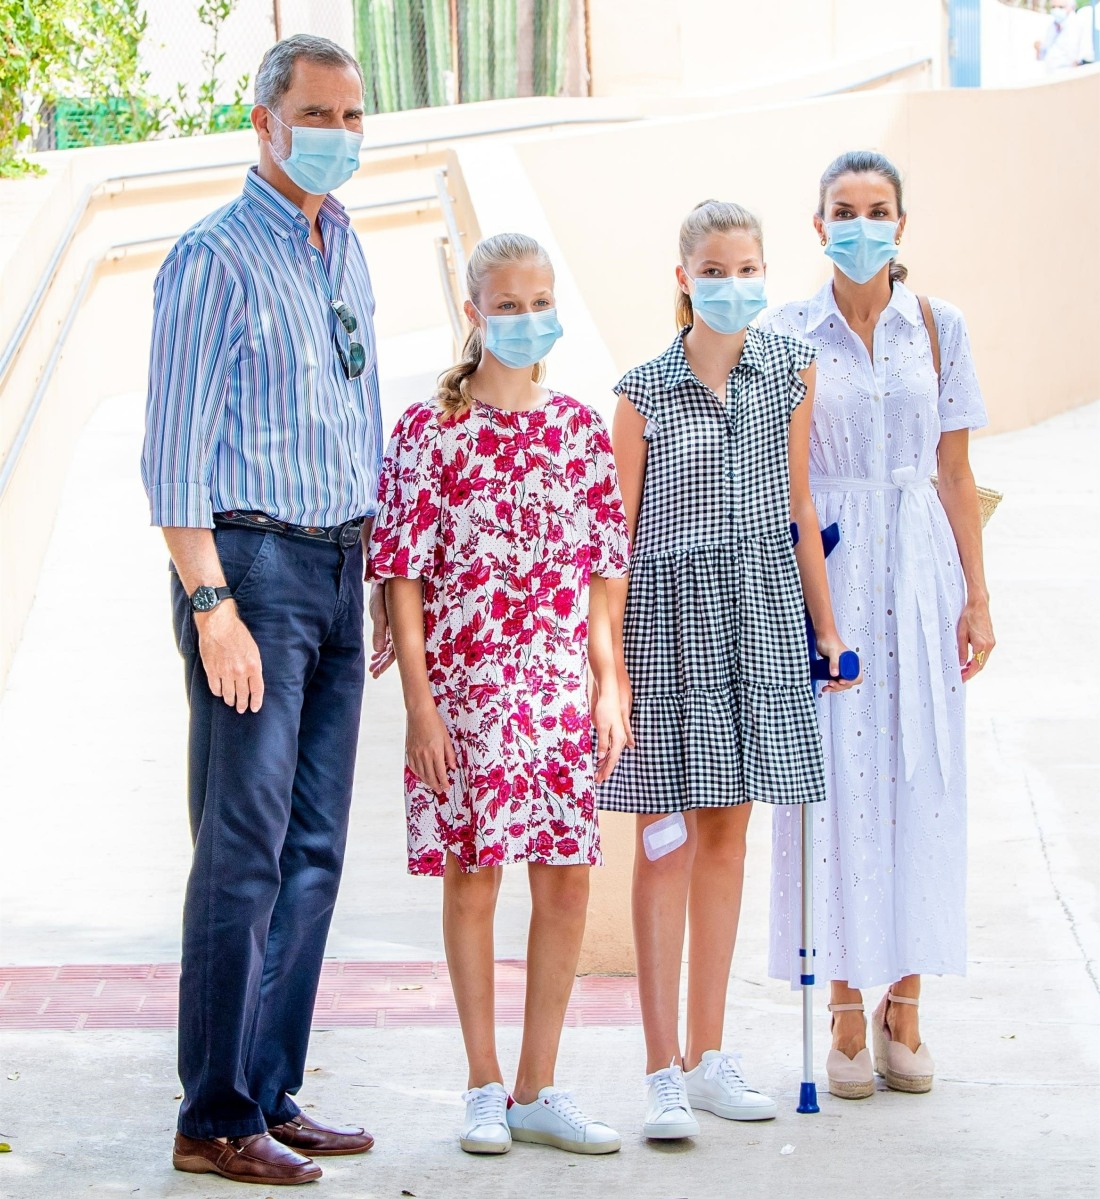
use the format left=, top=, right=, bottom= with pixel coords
left=599, top=200, right=852, bottom=1139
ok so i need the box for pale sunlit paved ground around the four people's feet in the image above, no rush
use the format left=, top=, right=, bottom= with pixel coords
left=0, top=398, right=1100, bottom=1199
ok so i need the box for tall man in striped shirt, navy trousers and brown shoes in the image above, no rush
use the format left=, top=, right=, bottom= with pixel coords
left=142, top=36, right=381, bottom=1185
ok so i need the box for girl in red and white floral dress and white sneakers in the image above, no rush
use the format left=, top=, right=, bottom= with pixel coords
left=371, top=234, right=627, bottom=1153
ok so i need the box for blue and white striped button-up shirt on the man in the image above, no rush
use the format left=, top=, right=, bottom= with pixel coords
left=142, top=168, right=383, bottom=529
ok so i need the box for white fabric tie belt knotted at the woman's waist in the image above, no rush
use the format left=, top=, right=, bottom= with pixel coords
left=810, top=466, right=951, bottom=787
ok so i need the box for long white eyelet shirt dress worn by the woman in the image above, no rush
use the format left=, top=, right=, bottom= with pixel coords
left=763, top=282, right=986, bottom=988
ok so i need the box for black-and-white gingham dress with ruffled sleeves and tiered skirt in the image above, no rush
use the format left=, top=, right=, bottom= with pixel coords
left=599, top=329, right=824, bottom=813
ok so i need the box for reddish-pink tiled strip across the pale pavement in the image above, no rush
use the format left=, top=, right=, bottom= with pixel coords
left=0, top=962, right=639, bottom=1031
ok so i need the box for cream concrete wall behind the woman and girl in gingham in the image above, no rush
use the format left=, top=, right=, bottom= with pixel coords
left=519, top=68, right=1100, bottom=430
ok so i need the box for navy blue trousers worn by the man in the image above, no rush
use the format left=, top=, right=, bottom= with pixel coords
left=172, top=528, right=365, bottom=1138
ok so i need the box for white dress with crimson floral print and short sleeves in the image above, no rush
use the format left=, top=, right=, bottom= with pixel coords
left=371, top=393, right=627, bottom=875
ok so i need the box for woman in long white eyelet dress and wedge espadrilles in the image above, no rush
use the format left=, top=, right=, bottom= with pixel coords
left=763, top=151, right=993, bottom=1098
